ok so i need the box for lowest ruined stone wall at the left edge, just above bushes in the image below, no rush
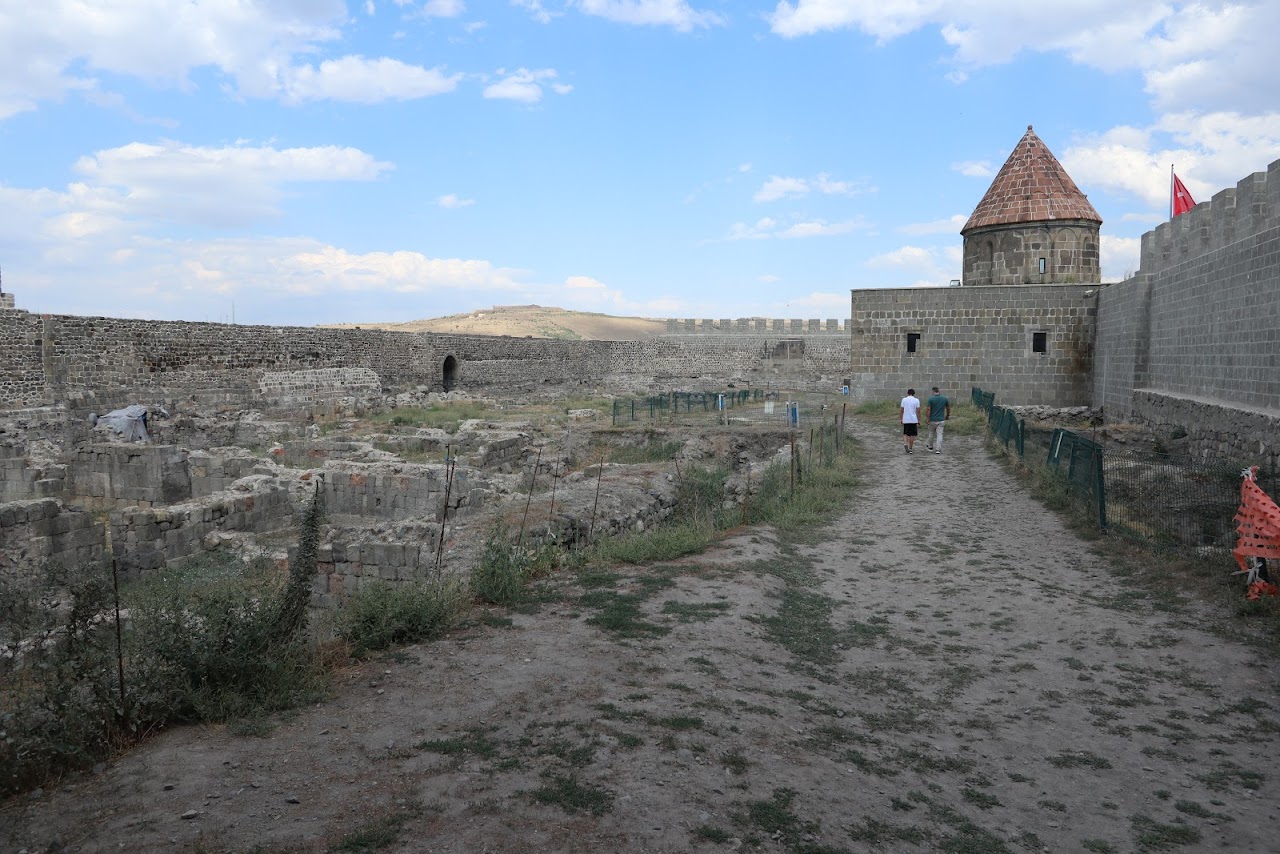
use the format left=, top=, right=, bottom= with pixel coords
left=0, top=498, right=106, bottom=579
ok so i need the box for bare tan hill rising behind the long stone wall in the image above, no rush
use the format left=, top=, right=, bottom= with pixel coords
left=321, top=306, right=667, bottom=341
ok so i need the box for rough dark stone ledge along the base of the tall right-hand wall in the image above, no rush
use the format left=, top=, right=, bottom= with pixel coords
left=1132, top=389, right=1280, bottom=467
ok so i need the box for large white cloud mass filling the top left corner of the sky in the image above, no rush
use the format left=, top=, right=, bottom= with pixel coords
left=0, top=0, right=453, bottom=119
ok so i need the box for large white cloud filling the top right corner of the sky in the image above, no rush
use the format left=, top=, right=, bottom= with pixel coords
left=768, top=0, right=1280, bottom=111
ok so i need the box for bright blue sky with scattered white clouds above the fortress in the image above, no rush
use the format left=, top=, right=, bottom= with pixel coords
left=0, top=0, right=1280, bottom=325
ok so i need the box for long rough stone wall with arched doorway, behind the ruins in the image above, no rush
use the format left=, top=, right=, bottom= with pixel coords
left=0, top=311, right=849, bottom=419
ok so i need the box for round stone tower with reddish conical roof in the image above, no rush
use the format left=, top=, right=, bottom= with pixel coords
left=960, top=124, right=1102, bottom=286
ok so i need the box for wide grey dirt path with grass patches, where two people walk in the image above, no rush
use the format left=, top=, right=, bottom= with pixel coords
left=0, top=428, right=1280, bottom=853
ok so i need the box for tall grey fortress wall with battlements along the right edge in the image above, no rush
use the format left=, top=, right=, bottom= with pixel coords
left=1092, top=160, right=1280, bottom=463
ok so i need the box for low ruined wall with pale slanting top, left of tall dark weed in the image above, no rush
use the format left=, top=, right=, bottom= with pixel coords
left=111, top=484, right=298, bottom=580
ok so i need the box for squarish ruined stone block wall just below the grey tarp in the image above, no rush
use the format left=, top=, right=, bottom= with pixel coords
left=67, top=443, right=192, bottom=510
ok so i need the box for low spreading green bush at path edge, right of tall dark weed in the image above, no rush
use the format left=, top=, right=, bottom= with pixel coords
left=337, top=579, right=467, bottom=656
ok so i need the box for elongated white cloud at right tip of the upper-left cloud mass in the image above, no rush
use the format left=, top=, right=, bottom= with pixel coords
left=284, top=56, right=462, bottom=104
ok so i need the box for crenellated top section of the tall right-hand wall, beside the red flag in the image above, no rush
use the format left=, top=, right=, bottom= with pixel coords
left=1142, top=160, right=1280, bottom=275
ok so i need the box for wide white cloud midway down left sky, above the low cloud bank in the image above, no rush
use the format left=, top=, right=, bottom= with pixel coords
left=63, top=142, right=393, bottom=227
